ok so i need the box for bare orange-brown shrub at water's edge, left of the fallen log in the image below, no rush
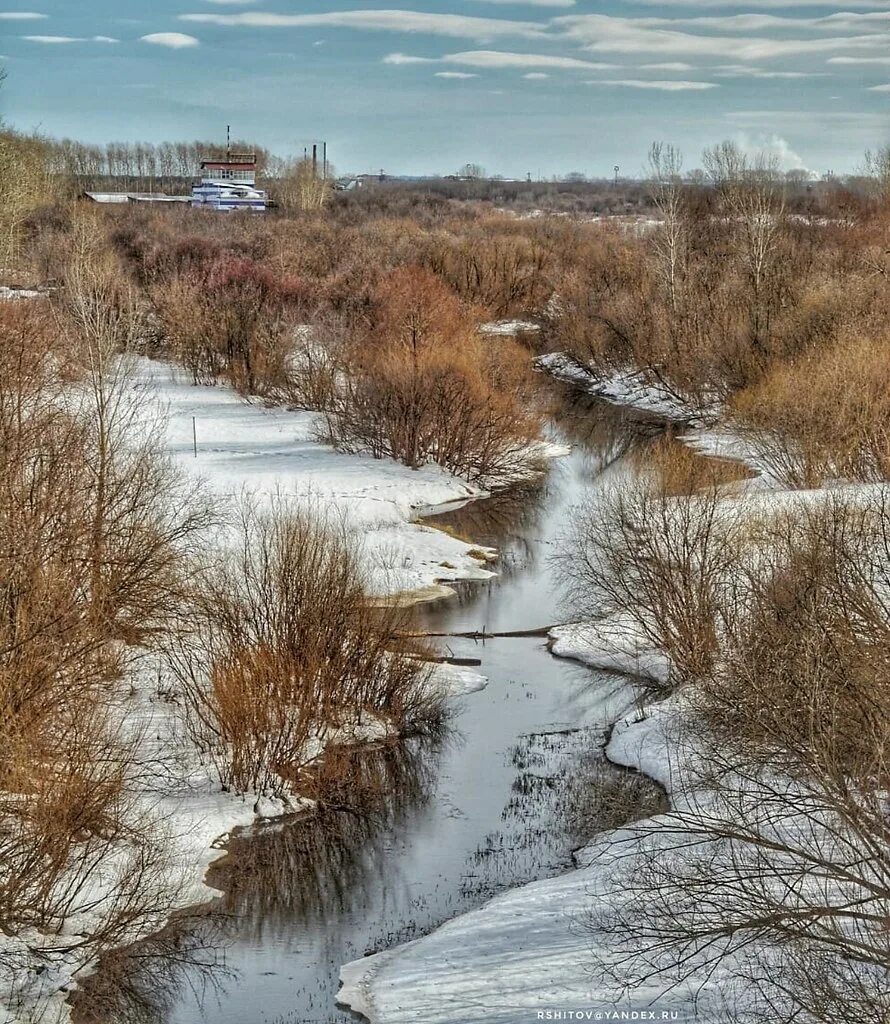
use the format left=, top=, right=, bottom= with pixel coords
left=170, top=501, right=435, bottom=793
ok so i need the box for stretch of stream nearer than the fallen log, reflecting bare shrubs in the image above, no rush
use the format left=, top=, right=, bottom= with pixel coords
left=78, top=640, right=630, bottom=1024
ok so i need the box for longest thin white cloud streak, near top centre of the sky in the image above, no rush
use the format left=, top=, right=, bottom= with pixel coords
left=179, top=10, right=545, bottom=41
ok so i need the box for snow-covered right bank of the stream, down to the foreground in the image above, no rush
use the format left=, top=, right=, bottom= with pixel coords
left=339, top=372, right=879, bottom=1024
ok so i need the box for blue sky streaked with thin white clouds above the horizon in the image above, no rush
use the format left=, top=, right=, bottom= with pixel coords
left=0, top=0, right=890, bottom=176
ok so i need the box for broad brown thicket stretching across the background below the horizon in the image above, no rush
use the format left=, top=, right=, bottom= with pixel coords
left=15, top=143, right=890, bottom=473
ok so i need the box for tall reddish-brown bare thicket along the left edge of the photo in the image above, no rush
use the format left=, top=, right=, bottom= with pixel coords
left=0, top=303, right=189, bottom=974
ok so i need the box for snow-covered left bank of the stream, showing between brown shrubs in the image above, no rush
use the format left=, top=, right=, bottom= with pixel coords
left=0, top=358, right=559, bottom=1024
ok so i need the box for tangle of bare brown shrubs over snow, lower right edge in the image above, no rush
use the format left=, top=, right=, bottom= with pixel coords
left=581, top=495, right=890, bottom=1022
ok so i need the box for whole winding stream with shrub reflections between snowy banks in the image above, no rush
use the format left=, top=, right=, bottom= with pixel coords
left=76, top=385, right=661, bottom=1024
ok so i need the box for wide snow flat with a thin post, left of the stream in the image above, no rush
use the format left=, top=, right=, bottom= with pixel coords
left=137, top=359, right=503, bottom=597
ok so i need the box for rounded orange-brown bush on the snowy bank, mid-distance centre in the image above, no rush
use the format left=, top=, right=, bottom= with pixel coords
left=325, top=268, right=540, bottom=480
